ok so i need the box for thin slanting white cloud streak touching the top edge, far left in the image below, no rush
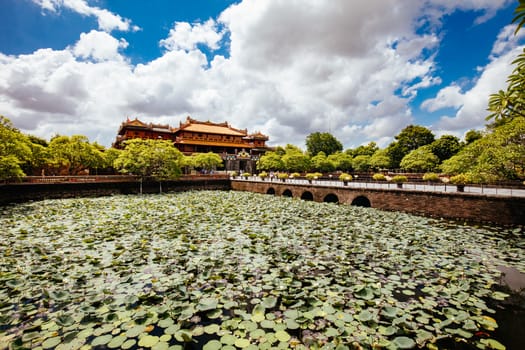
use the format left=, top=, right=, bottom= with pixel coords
left=32, top=0, right=140, bottom=32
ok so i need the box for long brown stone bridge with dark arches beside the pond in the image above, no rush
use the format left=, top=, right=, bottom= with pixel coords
left=231, top=180, right=525, bottom=225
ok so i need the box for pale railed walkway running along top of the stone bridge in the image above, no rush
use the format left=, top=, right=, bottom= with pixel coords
left=235, top=176, right=525, bottom=197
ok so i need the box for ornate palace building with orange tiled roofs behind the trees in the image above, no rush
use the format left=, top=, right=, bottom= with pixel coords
left=113, top=117, right=269, bottom=173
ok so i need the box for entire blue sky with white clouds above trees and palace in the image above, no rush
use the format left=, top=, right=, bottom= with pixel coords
left=0, top=0, right=525, bottom=149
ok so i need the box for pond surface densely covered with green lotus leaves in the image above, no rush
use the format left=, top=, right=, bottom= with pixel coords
left=0, top=191, right=525, bottom=350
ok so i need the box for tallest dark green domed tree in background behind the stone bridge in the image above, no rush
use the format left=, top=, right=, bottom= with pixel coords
left=387, top=125, right=435, bottom=168
